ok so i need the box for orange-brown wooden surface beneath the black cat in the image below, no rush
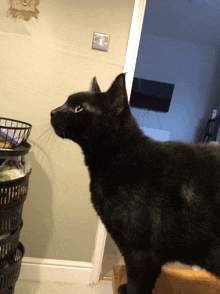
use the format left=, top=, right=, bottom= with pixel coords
left=113, top=265, right=220, bottom=294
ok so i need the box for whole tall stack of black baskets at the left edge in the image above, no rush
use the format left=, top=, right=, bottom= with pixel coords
left=0, top=117, right=32, bottom=294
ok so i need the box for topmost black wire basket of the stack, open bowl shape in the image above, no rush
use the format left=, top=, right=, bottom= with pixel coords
left=0, top=117, right=32, bottom=149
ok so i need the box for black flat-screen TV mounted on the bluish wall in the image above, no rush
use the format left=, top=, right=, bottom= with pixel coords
left=130, top=78, right=175, bottom=112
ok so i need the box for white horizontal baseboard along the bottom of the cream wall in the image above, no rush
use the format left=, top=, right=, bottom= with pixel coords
left=19, top=257, right=92, bottom=285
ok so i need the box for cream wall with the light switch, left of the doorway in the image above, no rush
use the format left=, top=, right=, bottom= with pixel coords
left=0, top=0, right=134, bottom=262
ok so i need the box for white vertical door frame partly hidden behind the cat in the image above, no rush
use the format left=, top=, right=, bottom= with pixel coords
left=90, top=0, right=147, bottom=284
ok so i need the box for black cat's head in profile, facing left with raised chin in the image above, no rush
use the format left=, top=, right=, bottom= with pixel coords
left=51, top=74, right=131, bottom=144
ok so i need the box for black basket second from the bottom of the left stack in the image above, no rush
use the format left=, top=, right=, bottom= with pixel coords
left=0, top=222, right=23, bottom=263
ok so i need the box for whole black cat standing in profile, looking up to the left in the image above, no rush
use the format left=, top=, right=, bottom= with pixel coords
left=51, top=74, right=220, bottom=294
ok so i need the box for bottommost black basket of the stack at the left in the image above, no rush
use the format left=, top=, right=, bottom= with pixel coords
left=0, top=242, right=25, bottom=294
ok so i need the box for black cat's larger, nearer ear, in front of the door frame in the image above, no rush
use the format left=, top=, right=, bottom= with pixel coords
left=107, top=73, right=128, bottom=115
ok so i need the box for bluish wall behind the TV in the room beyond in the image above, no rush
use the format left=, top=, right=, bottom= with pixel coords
left=132, top=34, right=220, bottom=142
